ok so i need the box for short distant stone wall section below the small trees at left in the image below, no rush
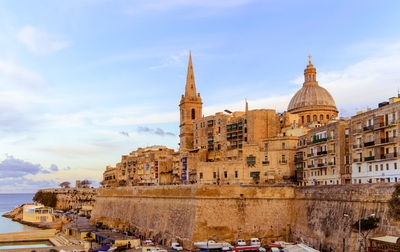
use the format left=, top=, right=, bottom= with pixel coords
left=40, top=188, right=97, bottom=210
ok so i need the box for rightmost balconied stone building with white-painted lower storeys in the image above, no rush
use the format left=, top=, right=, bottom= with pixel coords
left=350, top=97, right=400, bottom=183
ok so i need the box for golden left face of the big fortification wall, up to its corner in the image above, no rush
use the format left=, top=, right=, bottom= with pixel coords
left=92, top=185, right=294, bottom=247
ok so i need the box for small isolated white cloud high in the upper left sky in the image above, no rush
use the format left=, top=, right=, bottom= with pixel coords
left=17, top=25, right=71, bottom=55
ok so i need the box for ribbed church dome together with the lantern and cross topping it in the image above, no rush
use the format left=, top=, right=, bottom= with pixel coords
left=288, top=57, right=337, bottom=113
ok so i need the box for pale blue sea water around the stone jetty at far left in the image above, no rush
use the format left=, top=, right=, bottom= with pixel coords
left=0, top=193, right=38, bottom=233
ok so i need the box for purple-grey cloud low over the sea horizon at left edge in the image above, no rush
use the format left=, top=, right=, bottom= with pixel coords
left=0, top=155, right=58, bottom=178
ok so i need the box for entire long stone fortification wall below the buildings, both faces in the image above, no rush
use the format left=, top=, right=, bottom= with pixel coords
left=91, top=184, right=400, bottom=251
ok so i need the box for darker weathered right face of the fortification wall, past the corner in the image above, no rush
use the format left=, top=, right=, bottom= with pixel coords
left=291, top=184, right=400, bottom=251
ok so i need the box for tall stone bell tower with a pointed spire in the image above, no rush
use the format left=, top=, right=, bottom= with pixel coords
left=179, top=53, right=203, bottom=150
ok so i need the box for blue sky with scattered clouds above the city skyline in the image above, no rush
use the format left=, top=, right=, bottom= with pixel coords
left=0, top=0, right=400, bottom=193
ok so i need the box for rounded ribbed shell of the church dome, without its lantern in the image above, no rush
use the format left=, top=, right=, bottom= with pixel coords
left=288, top=84, right=337, bottom=112
